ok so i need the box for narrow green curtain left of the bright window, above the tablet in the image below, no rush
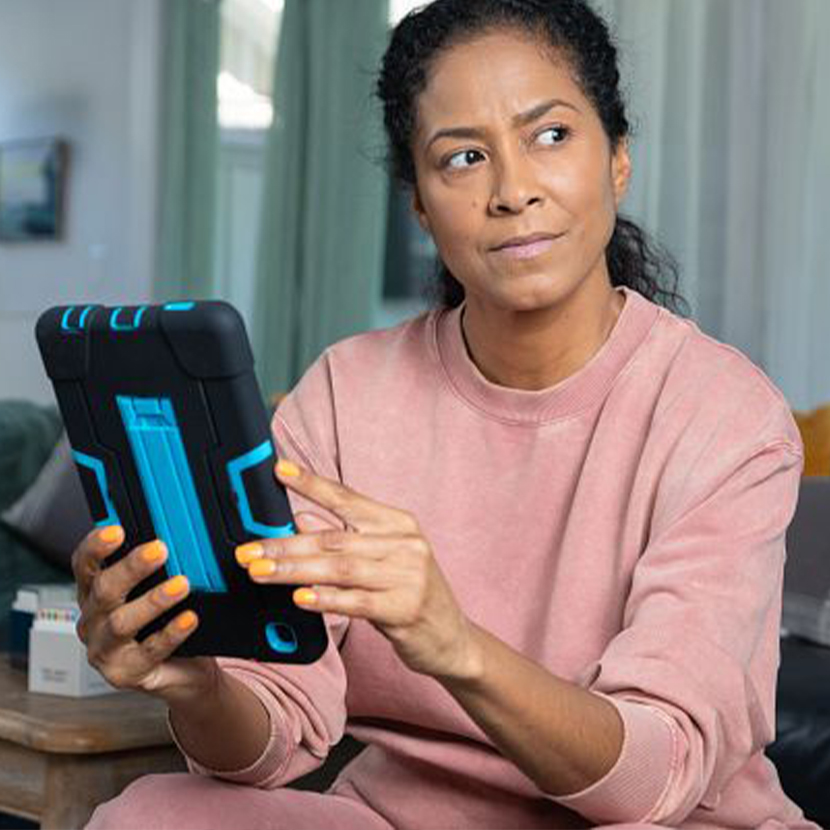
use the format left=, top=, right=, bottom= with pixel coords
left=154, top=0, right=219, bottom=300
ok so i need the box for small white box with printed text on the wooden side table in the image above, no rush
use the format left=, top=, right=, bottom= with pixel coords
left=29, top=606, right=118, bottom=697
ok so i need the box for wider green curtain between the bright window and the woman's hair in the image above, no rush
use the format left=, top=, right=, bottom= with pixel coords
left=252, top=0, right=388, bottom=395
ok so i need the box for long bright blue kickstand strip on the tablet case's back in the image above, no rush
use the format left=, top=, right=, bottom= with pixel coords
left=116, top=395, right=227, bottom=592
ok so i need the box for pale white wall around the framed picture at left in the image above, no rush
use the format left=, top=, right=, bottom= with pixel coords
left=0, top=0, right=160, bottom=401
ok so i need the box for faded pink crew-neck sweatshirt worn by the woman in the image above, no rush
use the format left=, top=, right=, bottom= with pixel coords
left=171, top=289, right=816, bottom=830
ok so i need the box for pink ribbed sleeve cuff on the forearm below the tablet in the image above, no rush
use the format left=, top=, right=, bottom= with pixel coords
left=167, top=668, right=291, bottom=786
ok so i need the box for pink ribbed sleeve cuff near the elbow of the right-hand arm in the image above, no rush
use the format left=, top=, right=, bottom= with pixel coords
left=548, top=692, right=677, bottom=823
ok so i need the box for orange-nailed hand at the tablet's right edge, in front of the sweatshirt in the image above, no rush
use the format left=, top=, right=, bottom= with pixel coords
left=237, top=461, right=478, bottom=679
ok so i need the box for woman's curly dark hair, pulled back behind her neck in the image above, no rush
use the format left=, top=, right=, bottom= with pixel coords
left=376, top=0, right=688, bottom=314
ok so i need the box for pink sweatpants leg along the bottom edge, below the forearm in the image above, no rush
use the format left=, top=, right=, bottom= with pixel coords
left=86, top=773, right=394, bottom=830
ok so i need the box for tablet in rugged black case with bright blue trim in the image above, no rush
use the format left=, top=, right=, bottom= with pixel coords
left=36, top=301, right=327, bottom=663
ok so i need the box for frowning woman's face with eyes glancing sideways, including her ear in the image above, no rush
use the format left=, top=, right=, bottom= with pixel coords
left=413, top=31, right=630, bottom=311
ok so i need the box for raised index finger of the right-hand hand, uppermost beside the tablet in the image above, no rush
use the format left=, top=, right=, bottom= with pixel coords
left=274, top=459, right=417, bottom=533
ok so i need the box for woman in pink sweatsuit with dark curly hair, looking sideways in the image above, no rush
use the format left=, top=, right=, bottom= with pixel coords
left=83, top=0, right=815, bottom=830
